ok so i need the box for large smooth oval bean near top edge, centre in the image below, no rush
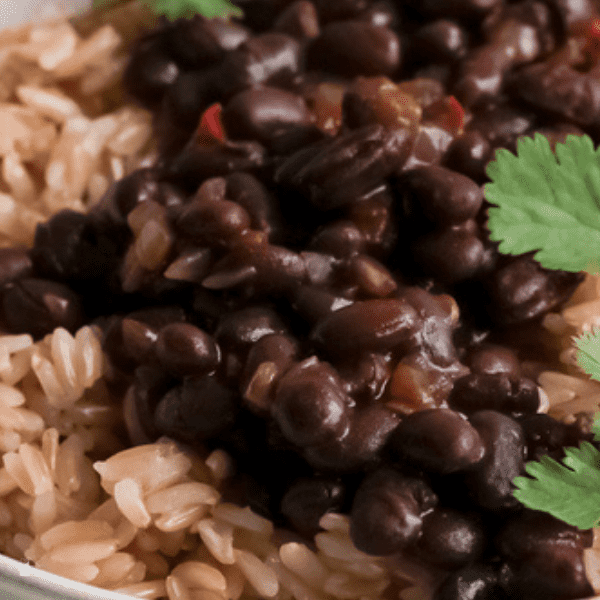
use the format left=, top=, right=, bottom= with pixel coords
left=307, top=21, right=401, bottom=77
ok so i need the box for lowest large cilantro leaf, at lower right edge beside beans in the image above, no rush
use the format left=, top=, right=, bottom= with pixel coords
left=513, top=442, right=600, bottom=529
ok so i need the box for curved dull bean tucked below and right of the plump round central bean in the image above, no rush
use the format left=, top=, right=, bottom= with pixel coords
left=304, top=405, right=399, bottom=473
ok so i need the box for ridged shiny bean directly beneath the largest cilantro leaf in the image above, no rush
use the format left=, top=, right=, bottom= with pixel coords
left=486, top=255, right=582, bottom=323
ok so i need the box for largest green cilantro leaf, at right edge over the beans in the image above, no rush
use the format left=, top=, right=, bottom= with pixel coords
left=484, top=133, right=600, bottom=272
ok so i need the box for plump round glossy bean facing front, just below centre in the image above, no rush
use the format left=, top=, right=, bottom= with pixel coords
left=271, top=357, right=352, bottom=446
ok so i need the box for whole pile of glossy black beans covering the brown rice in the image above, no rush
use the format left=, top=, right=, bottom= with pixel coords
left=0, top=0, right=600, bottom=600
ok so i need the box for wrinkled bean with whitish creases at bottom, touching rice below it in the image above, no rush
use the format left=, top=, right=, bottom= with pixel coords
left=350, top=468, right=437, bottom=556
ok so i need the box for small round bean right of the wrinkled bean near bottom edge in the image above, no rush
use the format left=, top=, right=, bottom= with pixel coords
left=415, top=507, right=486, bottom=569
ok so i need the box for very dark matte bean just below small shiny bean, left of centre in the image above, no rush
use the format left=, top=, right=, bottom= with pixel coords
left=154, top=376, right=239, bottom=443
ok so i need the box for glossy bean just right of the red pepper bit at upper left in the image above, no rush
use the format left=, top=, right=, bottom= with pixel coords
left=222, top=86, right=311, bottom=145
